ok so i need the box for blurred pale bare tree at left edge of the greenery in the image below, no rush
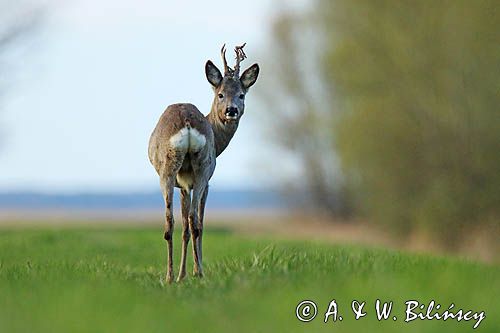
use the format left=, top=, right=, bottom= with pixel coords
left=259, top=13, right=350, bottom=217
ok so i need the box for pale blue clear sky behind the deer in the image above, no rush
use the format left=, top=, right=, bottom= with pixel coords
left=0, top=0, right=306, bottom=192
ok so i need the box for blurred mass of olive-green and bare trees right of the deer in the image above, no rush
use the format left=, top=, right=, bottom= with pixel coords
left=264, top=0, right=500, bottom=247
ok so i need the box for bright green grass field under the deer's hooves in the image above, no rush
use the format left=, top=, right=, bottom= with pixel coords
left=0, top=226, right=500, bottom=333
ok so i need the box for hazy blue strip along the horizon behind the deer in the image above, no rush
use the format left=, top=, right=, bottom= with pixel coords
left=0, top=189, right=287, bottom=210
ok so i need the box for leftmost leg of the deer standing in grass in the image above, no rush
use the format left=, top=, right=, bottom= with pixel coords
left=160, top=179, right=174, bottom=283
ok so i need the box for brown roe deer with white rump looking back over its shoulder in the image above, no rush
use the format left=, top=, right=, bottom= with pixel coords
left=148, top=44, right=259, bottom=283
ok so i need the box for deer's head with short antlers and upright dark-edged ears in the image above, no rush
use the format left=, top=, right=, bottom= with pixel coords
left=205, top=44, right=259, bottom=124
